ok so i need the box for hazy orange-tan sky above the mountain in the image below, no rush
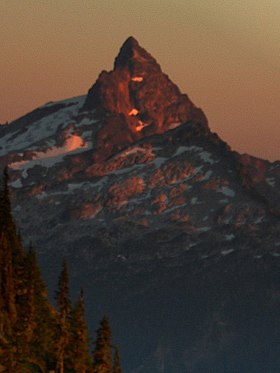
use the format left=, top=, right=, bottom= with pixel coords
left=0, top=0, right=280, bottom=160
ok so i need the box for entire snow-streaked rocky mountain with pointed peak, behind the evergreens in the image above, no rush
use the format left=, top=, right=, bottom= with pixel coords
left=0, top=37, right=280, bottom=373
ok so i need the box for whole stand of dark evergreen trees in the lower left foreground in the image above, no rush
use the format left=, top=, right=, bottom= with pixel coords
left=0, top=169, right=121, bottom=373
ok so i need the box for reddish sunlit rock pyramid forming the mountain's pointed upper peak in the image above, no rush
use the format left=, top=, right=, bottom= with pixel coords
left=83, top=37, right=207, bottom=160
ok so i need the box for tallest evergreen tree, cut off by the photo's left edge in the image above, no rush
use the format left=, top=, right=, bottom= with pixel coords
left=0, top=167, right=27, bottom=372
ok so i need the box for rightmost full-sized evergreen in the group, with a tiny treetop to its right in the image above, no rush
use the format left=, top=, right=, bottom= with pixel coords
left=93, top=316, right=112, bottom=373
